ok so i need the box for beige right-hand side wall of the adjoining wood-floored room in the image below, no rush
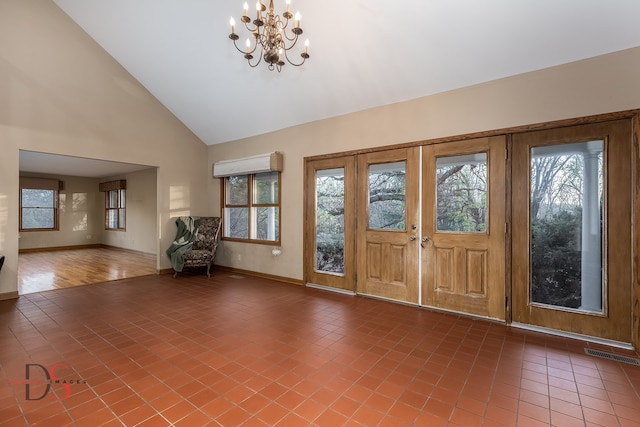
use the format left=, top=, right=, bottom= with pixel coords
left=100, top=168, right=159, bottom=254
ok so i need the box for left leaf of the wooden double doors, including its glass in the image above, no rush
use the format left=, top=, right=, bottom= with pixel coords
left=357, top=148, right=419, bottom=303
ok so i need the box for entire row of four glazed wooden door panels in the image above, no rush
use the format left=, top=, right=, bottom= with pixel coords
left=305, top=120, right=634, bottom=343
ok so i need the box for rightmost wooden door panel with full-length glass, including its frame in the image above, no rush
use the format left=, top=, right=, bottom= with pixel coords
left=512, top=120, right=632, bottom=342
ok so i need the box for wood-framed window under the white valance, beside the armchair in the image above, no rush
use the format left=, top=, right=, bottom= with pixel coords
left=222, top=172, right=280, bottom=244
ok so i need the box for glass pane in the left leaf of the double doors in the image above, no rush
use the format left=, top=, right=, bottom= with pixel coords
left=368, top=161, right=407, bottom=231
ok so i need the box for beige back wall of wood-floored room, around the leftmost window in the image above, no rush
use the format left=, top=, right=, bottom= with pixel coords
left=18, top=174, right=104, bottom=249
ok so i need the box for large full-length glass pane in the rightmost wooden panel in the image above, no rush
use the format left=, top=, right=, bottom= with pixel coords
left=530, top=141, right=604, bottom=313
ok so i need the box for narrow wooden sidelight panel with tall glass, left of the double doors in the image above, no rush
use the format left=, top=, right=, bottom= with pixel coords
left=304, top=156, right=355, bottom=291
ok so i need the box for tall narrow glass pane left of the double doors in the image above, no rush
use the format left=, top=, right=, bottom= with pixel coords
left=315, top=168, right=344, bottom=274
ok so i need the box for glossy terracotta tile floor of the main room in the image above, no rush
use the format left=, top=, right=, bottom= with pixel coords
left=0, top=273, right=640, bottom=427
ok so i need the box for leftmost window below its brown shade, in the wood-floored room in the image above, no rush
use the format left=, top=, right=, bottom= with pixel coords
left=20, top=188, right=58, bottom=231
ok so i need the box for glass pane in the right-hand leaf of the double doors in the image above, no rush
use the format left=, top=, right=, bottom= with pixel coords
left=436, top=153, right=488, bottom=233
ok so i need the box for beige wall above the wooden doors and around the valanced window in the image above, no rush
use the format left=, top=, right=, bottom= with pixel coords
left=209, top=48, right=640, bottom=279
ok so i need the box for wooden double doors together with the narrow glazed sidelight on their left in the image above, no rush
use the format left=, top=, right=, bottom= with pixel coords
left=305, top=136, right=506, bottom=318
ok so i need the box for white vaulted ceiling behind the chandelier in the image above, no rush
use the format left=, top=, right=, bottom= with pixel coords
left=53, top=0, right=640, bottom=145
